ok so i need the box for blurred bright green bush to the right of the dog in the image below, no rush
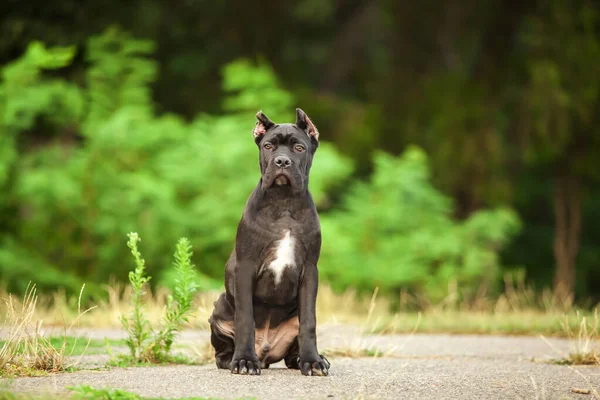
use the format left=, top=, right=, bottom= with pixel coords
left=319, top=148, right=519, bottom=301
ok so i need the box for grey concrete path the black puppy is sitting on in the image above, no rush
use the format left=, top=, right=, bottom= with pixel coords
left=5, top=326, right=600, bottom=400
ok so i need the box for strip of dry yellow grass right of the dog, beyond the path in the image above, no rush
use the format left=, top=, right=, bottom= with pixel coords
left=317, top=277, right=591, bottom=337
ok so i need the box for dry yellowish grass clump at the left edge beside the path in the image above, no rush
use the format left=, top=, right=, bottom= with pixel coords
left=0, top=285, right=95, bottom=377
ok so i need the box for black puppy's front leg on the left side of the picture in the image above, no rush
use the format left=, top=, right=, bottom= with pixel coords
left=230, top=261, right=260, bottom=375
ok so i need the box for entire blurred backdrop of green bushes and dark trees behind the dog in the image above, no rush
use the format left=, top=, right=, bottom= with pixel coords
left=0, top=0, right=600, bottom=300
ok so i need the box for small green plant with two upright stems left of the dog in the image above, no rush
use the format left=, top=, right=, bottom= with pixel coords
left=121, top=232, right=197, bottom=364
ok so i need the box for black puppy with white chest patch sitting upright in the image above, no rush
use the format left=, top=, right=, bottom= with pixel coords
left=209, top=109, right=329, bottom=375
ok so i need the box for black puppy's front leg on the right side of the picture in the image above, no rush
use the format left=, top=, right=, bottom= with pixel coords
left=298, top=265, right=330, bottom=375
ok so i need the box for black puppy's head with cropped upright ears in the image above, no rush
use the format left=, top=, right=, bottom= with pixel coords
left=253, top=108, right=319, bottom=192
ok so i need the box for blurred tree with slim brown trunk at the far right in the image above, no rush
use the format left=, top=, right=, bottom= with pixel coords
left=519, top=0, right=600, bottom=296
